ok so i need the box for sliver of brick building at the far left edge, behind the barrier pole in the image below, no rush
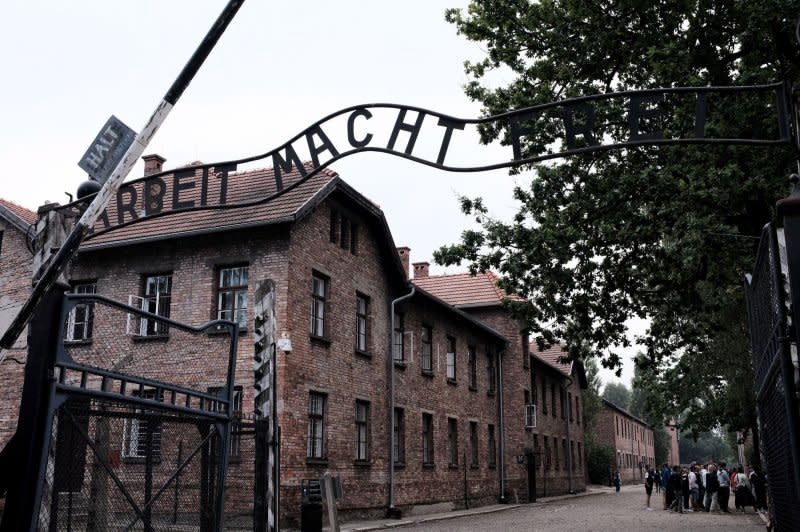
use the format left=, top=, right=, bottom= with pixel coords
left=0, top=199, right=37, bottom=449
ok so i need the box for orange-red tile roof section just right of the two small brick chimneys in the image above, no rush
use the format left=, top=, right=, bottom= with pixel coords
left=413, top=272, right=524, bottom=308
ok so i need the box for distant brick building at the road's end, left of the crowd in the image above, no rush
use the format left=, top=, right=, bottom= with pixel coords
left=597, top=399, right=656, bottom=482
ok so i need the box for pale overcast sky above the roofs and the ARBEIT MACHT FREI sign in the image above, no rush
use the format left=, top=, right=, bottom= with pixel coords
left=0, top=0, right=632, bottom=388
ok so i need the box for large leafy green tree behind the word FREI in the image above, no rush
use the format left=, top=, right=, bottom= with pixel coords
left=434, top=0, right=800, bottom=432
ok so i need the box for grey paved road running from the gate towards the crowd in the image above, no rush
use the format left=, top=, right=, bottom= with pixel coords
left=392, top=486, right=765, bottom=532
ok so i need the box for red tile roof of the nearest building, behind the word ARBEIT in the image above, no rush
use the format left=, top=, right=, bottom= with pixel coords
left=81, top=163, right=339, bottom=249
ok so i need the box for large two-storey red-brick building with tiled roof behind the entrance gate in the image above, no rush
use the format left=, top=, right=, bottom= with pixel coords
left=2, top=156, right=585, bottom=520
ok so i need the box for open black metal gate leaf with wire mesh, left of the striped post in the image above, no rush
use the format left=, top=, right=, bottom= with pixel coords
left=10, top=294, right=242, bottom=531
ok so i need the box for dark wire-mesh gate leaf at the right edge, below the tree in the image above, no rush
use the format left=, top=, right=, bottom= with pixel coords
left=745, top=224, right=800, bottom=531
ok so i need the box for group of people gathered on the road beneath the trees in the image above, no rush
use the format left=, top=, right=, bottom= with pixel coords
left=644, top=462, right=767, bottom=513
